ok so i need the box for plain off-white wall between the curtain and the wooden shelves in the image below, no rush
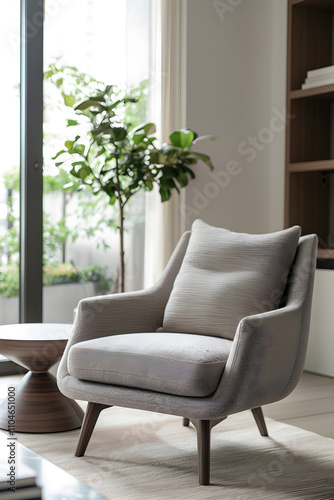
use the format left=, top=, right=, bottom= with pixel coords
left=182, top=0, right=287, bottom=233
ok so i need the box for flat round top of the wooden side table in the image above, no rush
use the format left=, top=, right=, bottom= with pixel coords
left=0, top=323, right=73, bottom=341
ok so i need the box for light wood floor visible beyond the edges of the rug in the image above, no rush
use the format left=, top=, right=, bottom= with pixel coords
left=0, top=372, right=334, bottom=439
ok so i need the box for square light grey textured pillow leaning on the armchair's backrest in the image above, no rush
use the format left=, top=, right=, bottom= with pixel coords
left=159, top=219, right=301, bottom=340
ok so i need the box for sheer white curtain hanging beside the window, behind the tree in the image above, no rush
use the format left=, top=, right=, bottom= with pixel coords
left=145, top=0, right=187, bottom=286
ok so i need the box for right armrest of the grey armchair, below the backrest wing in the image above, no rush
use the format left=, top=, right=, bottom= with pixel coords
left=215, top=305, right=308, bottom=415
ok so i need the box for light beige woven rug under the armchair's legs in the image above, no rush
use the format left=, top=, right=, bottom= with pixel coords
left=6, top=408, right=334, bottom=500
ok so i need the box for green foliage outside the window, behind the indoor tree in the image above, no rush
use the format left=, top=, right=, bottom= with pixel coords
left=0, top=66, right=123, bottom=297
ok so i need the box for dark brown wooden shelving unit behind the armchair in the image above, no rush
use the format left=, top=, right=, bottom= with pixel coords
left=285, top=0, right=334, bottom=268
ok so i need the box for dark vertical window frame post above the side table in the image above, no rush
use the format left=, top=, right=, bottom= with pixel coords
left=19, top=0, right=44, bottom=323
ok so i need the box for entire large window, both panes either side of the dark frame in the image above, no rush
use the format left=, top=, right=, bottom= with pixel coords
left=0, top=0, right=150, bottom=324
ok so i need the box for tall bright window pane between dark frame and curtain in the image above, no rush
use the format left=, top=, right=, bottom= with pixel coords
left=44, top=0, right=149, bottom=321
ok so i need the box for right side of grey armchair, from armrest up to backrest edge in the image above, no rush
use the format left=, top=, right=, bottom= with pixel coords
left=213, top=235, right=317, bottom=415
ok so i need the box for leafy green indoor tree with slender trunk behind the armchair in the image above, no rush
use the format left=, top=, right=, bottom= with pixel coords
left=54, top=86, right=213, bottom=292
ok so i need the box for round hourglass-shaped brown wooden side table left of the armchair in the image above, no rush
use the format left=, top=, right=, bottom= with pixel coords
left=0, top=323, right=84, bottom=433
